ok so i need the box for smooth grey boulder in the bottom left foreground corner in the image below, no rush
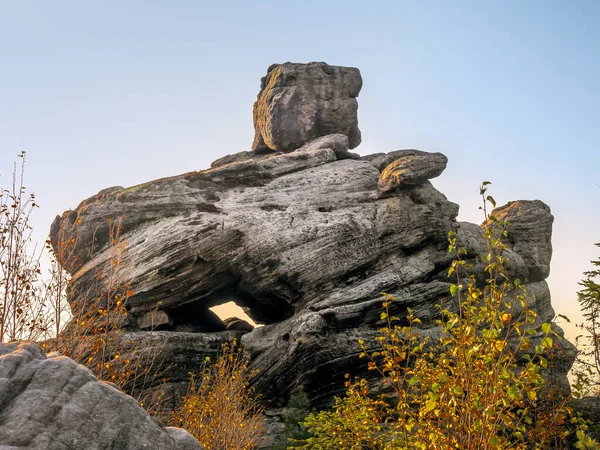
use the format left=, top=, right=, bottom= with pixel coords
left=0, top=342, right=202, bottom=450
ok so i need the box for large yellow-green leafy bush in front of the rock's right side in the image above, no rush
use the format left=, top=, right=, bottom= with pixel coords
left=302, top=183, right=578, bottom=450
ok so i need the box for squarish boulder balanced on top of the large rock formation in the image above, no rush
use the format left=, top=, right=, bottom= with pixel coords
left=252, top=62, right=362, bottom=152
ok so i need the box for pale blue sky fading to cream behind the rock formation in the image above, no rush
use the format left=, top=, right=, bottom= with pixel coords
left=0, top=0, right=600, bottom=336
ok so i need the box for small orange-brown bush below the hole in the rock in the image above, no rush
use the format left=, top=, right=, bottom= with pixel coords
left=171, top=341, right=264, bottom=450
